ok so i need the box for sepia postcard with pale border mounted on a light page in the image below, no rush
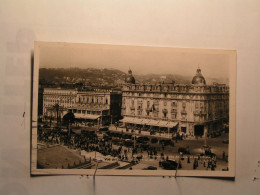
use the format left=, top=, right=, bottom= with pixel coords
left=31, top=42, right=236, bottom=177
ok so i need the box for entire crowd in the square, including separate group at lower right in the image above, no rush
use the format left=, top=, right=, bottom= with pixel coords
left=38, top=123, right=225, bottom=170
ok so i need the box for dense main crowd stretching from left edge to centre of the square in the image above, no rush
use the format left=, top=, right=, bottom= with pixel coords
left=38, top=125, right=175, bottom=165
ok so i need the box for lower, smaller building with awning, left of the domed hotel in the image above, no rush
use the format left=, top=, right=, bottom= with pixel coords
left=43, top=88, right=122, bottom=125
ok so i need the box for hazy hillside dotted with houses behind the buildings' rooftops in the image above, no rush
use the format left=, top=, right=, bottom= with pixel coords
left=39, top=68, right=228, bottom=86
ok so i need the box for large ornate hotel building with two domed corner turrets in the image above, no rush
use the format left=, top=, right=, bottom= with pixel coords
left=121, top=68, right=229, bottom=136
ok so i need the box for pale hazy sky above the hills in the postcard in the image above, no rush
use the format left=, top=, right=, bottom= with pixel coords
left=39, top=43, right=230, bottom=79
